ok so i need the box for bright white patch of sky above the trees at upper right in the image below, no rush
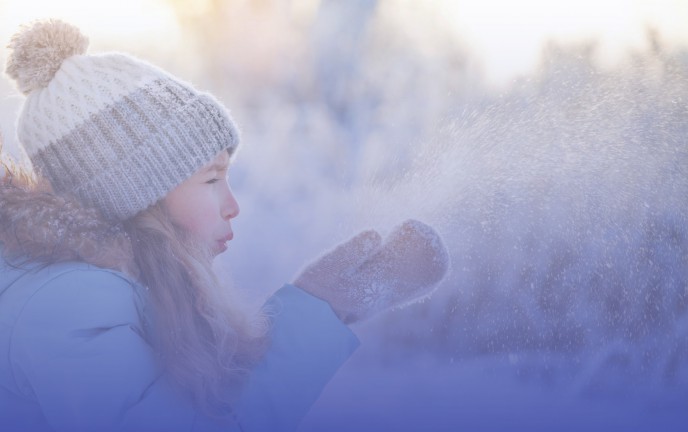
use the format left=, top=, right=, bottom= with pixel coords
left=433, top=0, right=688, bottom=87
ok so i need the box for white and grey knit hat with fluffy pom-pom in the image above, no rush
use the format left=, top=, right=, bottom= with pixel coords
left=6, top=20, right=239, bottom=221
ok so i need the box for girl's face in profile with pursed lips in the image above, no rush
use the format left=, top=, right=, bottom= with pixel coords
left=164, top=151, right=239, bottom=256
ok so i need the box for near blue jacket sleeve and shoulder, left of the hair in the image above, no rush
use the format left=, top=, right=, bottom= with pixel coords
left=10, top=269, right=228, bottom=432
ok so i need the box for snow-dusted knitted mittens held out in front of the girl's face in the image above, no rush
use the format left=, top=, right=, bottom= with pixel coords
left=294, top=220, right=449, bottom=323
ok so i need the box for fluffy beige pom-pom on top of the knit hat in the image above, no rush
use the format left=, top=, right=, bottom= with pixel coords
left=6, top=20, right=88, bottom=94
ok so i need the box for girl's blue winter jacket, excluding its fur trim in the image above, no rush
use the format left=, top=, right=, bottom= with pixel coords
left=0, top=259, right=358, bottom=432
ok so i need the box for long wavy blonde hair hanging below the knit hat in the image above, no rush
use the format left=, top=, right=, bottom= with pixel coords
left=124, top=202, right=265, bottom=413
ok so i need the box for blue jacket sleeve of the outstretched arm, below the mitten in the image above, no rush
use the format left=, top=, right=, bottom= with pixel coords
left=235, top=285, right=359, bottom=432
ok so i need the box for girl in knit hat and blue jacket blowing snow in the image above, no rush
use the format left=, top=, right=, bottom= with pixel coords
left=0, top=21, right=448, bottom=431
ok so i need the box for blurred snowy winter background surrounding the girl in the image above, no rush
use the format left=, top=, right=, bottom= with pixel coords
left=0, top=0, right=688, bottom=432
